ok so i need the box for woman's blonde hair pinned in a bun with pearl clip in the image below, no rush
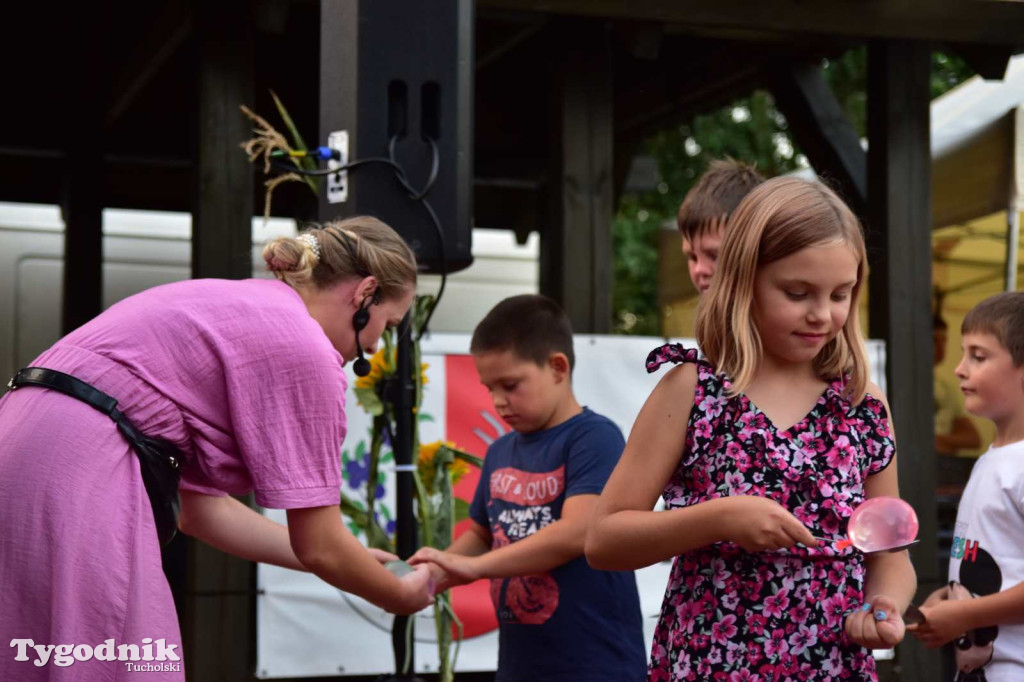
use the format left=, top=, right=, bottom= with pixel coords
left=263, top=216, right=416, bottom=299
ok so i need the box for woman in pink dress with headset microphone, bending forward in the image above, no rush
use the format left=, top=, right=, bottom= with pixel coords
left=0, top=217, right=432, bottom=681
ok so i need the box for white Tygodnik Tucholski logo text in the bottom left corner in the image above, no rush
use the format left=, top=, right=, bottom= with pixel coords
left=10, top=637, right=181, bottom=672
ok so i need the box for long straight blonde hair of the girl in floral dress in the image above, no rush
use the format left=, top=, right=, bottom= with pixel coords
left=696, top=177, right=868, bottom=403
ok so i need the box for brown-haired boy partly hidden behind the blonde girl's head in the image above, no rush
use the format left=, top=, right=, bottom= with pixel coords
left=676, top=158, right=765, bottom=295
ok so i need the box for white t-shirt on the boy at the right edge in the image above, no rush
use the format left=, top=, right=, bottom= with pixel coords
left=949, top=440, right=1024, bottom=682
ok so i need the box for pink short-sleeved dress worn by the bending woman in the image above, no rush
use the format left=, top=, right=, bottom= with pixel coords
left=0, top=280, right=345, bottom=682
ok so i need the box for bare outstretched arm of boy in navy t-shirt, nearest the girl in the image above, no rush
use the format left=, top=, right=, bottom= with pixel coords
left=409, top=495, right=597, bottom=585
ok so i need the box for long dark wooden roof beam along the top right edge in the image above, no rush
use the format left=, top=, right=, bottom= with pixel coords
left=479, top=0, right=1024, bottom=45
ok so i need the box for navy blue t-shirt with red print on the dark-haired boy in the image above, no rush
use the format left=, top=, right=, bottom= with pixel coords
left=469, top=409, right=647, bottom=682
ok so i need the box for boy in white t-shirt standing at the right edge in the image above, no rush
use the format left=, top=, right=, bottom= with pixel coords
left=907, top=292, right=1024, bottom=682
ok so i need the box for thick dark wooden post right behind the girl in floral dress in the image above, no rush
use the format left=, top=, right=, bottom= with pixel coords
left=867, top=41, right=944, bottom=682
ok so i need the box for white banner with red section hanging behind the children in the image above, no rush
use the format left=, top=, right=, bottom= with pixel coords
left=256, top=334, right=885, bottom=678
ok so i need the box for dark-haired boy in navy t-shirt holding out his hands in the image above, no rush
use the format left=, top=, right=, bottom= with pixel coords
left=411, top=295, right=647, bottom=682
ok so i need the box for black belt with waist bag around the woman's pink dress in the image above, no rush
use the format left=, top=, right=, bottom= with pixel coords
left=7, top=367, right=184, bottom=545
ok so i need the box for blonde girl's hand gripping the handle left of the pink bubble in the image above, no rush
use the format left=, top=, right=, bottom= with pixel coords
left=721, top=495, right=818, bottom=552
